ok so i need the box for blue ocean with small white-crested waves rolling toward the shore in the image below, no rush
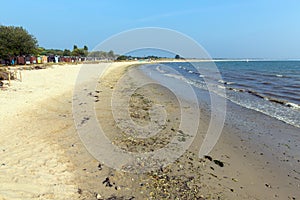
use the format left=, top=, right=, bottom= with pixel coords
left=141, top=61, right=300, bottom=128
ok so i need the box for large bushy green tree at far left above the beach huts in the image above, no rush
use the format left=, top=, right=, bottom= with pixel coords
left=0, top=26, right=38, bottom=59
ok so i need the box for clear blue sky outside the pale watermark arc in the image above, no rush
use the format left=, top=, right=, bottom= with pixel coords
left=0, top=0, right=300, bottom=58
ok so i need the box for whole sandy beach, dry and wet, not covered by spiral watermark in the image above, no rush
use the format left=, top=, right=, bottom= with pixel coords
left=0, top=62, right=300, bottom=200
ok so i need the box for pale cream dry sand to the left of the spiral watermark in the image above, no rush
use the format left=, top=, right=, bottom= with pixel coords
left=0, top=66, right=79, bottom=199
